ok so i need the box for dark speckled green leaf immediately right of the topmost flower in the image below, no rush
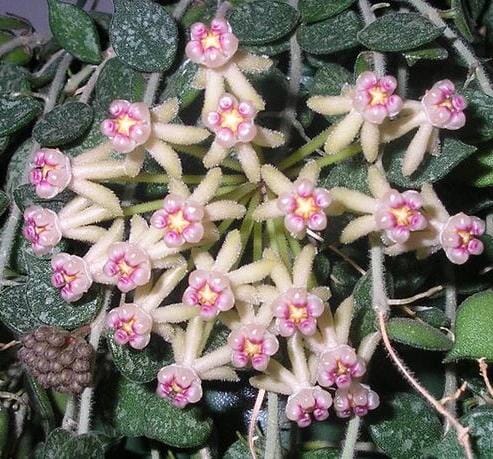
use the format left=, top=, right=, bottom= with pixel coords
left=298, top=10, right=363, bottom=54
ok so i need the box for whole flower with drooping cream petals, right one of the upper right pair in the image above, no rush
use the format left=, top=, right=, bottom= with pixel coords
left=382, top=80, right=467, bottom=176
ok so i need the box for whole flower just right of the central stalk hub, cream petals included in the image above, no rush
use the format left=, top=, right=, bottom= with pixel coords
left=253, top=161, right=332, bottom=238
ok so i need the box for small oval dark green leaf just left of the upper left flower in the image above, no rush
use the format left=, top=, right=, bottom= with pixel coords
left=33, top=102, right=94, bottom=147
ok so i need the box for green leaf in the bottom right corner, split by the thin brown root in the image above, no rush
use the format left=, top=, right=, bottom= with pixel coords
left=427, top=406, right=493, bottom=459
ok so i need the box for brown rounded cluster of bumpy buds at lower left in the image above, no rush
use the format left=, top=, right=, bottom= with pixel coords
left=17, top=325, right=94, bottom=394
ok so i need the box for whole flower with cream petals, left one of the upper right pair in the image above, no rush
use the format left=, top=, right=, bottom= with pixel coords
left=307, top=72, right=403, bottom=162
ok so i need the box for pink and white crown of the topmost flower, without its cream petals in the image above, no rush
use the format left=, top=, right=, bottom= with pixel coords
left=185, top=18, right=238, bottom=68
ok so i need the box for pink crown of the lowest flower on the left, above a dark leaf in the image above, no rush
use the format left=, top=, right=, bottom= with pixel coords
left=157, top=364, right=202, bottom=408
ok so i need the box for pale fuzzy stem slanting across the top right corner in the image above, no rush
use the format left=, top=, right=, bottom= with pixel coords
left=406, top=0, right=493, bottom=96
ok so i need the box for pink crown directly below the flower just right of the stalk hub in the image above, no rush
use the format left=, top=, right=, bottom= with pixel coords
left=272, top=288, right=324, bottom=337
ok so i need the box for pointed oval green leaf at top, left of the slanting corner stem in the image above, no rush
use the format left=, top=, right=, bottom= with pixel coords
left=358, top=13, right=442, bottom=52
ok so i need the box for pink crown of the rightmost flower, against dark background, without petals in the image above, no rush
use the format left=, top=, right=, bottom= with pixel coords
left=440, top=212, right=485, bottom=265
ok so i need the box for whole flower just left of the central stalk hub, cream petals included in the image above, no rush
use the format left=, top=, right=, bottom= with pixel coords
left=151, top=168, right=246, bottom=249
